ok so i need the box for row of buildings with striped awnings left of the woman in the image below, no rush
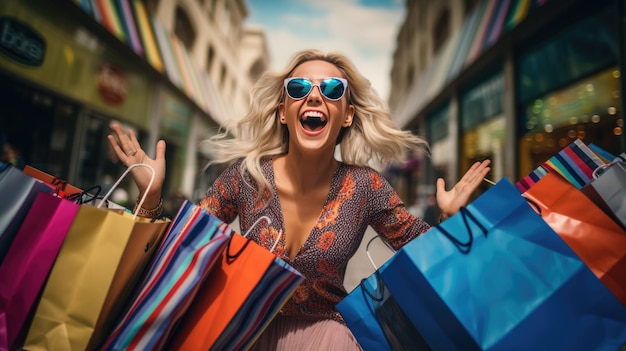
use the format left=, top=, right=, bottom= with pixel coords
left=0, top=0, right=268, bottom=203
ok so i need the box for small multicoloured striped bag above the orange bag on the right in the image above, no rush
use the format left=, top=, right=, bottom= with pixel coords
left=515, top=139, right=606, bottom=192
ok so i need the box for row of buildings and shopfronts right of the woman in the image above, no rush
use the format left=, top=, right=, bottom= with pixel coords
left=389, top=0, right=626, bottom=202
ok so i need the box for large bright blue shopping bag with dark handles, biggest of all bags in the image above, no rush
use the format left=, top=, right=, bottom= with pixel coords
left=381, top=179, right=626, bottom=350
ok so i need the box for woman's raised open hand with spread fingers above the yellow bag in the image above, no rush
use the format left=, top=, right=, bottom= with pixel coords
left=107, top=122, right=165, bottom=209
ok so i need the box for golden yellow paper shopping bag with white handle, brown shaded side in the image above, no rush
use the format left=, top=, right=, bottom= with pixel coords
left=23, top=165, right=169, bottom=351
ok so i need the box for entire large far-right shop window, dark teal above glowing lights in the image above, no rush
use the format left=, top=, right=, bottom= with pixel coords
left=516, top=7, right=624, bottom=177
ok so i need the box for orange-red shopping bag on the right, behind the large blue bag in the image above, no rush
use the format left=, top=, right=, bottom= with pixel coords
left=522, top=173, right=626, bottom=306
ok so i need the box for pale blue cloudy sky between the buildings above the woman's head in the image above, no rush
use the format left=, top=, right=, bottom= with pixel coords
left=246, top=0, right=405, bottom=100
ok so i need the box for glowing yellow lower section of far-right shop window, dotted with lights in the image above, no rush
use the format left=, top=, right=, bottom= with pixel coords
left=520, top=67, right=624, bottom=177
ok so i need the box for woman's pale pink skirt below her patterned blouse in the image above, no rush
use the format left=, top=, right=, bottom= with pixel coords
left=250, top=314, right=361, bottom=351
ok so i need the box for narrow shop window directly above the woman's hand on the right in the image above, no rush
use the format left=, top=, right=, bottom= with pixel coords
left=459, top=72, right=506, bottom=186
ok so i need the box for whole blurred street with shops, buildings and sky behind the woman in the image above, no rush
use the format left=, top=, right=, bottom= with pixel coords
left=0, top=0, right=626, bottom=290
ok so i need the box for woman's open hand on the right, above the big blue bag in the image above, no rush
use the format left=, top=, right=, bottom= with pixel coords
left=437, top=160, right=491, bottom=218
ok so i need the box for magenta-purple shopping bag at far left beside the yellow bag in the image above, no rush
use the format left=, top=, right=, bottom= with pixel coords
left=0, top=192, right=80, bottom=350
